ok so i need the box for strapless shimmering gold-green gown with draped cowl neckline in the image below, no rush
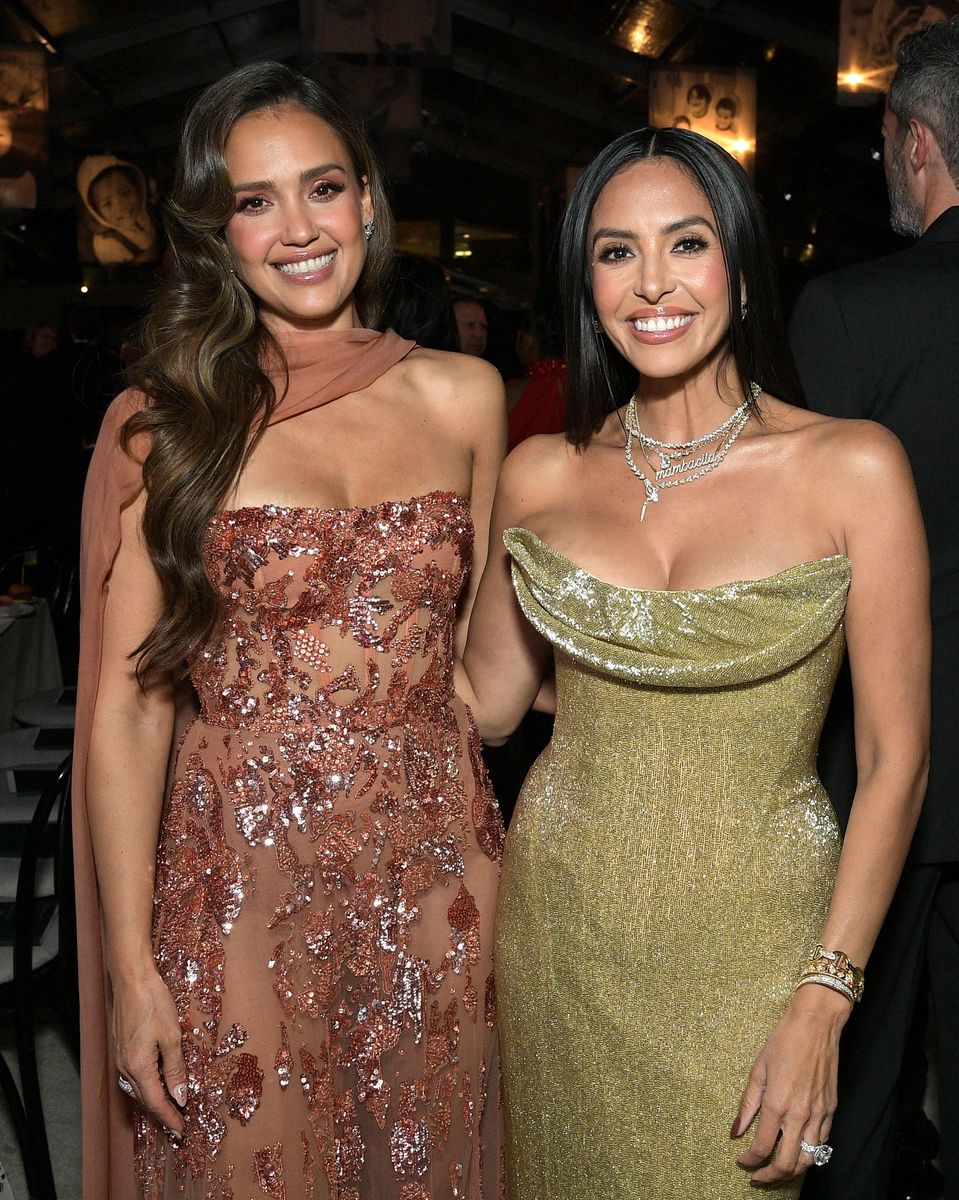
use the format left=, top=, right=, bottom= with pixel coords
left=495, top=529, right=850, bottom=1200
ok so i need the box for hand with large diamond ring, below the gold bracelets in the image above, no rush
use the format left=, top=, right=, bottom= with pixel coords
left=731, top=984, right=850, bottom=1183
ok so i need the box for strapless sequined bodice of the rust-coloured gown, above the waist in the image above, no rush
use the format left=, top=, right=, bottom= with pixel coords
left=191, top=492, right=473, bottom=728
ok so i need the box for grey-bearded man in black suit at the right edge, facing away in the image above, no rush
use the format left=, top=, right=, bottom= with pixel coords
left=791, top=17, right=959, bottom=1200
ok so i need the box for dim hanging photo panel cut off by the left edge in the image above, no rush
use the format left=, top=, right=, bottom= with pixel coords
left=0, top=46, right=48, bottom=209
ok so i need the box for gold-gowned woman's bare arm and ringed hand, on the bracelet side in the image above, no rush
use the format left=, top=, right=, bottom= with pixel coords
left=733, top=424, right=930, bottom=1183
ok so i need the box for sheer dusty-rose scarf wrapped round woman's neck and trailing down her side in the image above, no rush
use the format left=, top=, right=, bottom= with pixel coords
left=73, top=329, right=414, bottom=1200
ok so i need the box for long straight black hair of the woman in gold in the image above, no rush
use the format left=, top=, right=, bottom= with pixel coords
left=559, top=128, right=805, bottom=446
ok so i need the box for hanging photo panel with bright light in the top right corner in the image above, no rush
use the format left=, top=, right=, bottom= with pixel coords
left=837, top=0, right=959, bottom=104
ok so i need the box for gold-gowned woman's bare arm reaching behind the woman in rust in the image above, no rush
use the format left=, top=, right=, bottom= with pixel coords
left=456, top=439, right=551, bottom=743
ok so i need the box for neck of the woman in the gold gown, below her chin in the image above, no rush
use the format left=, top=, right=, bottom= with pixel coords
left=636, top=360, right=745, bottom=442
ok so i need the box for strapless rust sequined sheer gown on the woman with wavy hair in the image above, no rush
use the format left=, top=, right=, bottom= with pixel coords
left=137, top=492, right=503, bottom=1200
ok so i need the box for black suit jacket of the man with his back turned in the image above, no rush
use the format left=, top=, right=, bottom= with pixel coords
left=790, top=206, right=959, bottom=863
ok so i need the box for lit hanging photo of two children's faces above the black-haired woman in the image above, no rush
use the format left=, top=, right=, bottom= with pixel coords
left=649, top=66, right=756, bottom=176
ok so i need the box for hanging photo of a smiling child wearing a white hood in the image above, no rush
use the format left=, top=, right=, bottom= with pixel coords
left=77, top=155, right=157, bottom=265
